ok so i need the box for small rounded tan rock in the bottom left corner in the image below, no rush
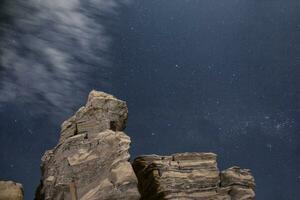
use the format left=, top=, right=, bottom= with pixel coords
left=0, top=181, right=23, bottom=200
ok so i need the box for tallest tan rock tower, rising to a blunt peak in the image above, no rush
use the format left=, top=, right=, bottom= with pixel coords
left=36, top=91, right=140, bottom=200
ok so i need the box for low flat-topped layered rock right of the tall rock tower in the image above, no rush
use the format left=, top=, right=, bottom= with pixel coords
left=133, top=153, right=255, bottom=200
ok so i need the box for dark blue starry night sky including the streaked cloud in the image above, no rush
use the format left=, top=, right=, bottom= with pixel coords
left=0, top=0, right=300, bottom=200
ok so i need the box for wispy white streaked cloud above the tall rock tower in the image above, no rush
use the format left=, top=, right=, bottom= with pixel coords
left=0, top=0, right=128, bottom=115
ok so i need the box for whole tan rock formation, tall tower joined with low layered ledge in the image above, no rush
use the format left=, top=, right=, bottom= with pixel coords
left=32, top=91, right=255, bottom=200
